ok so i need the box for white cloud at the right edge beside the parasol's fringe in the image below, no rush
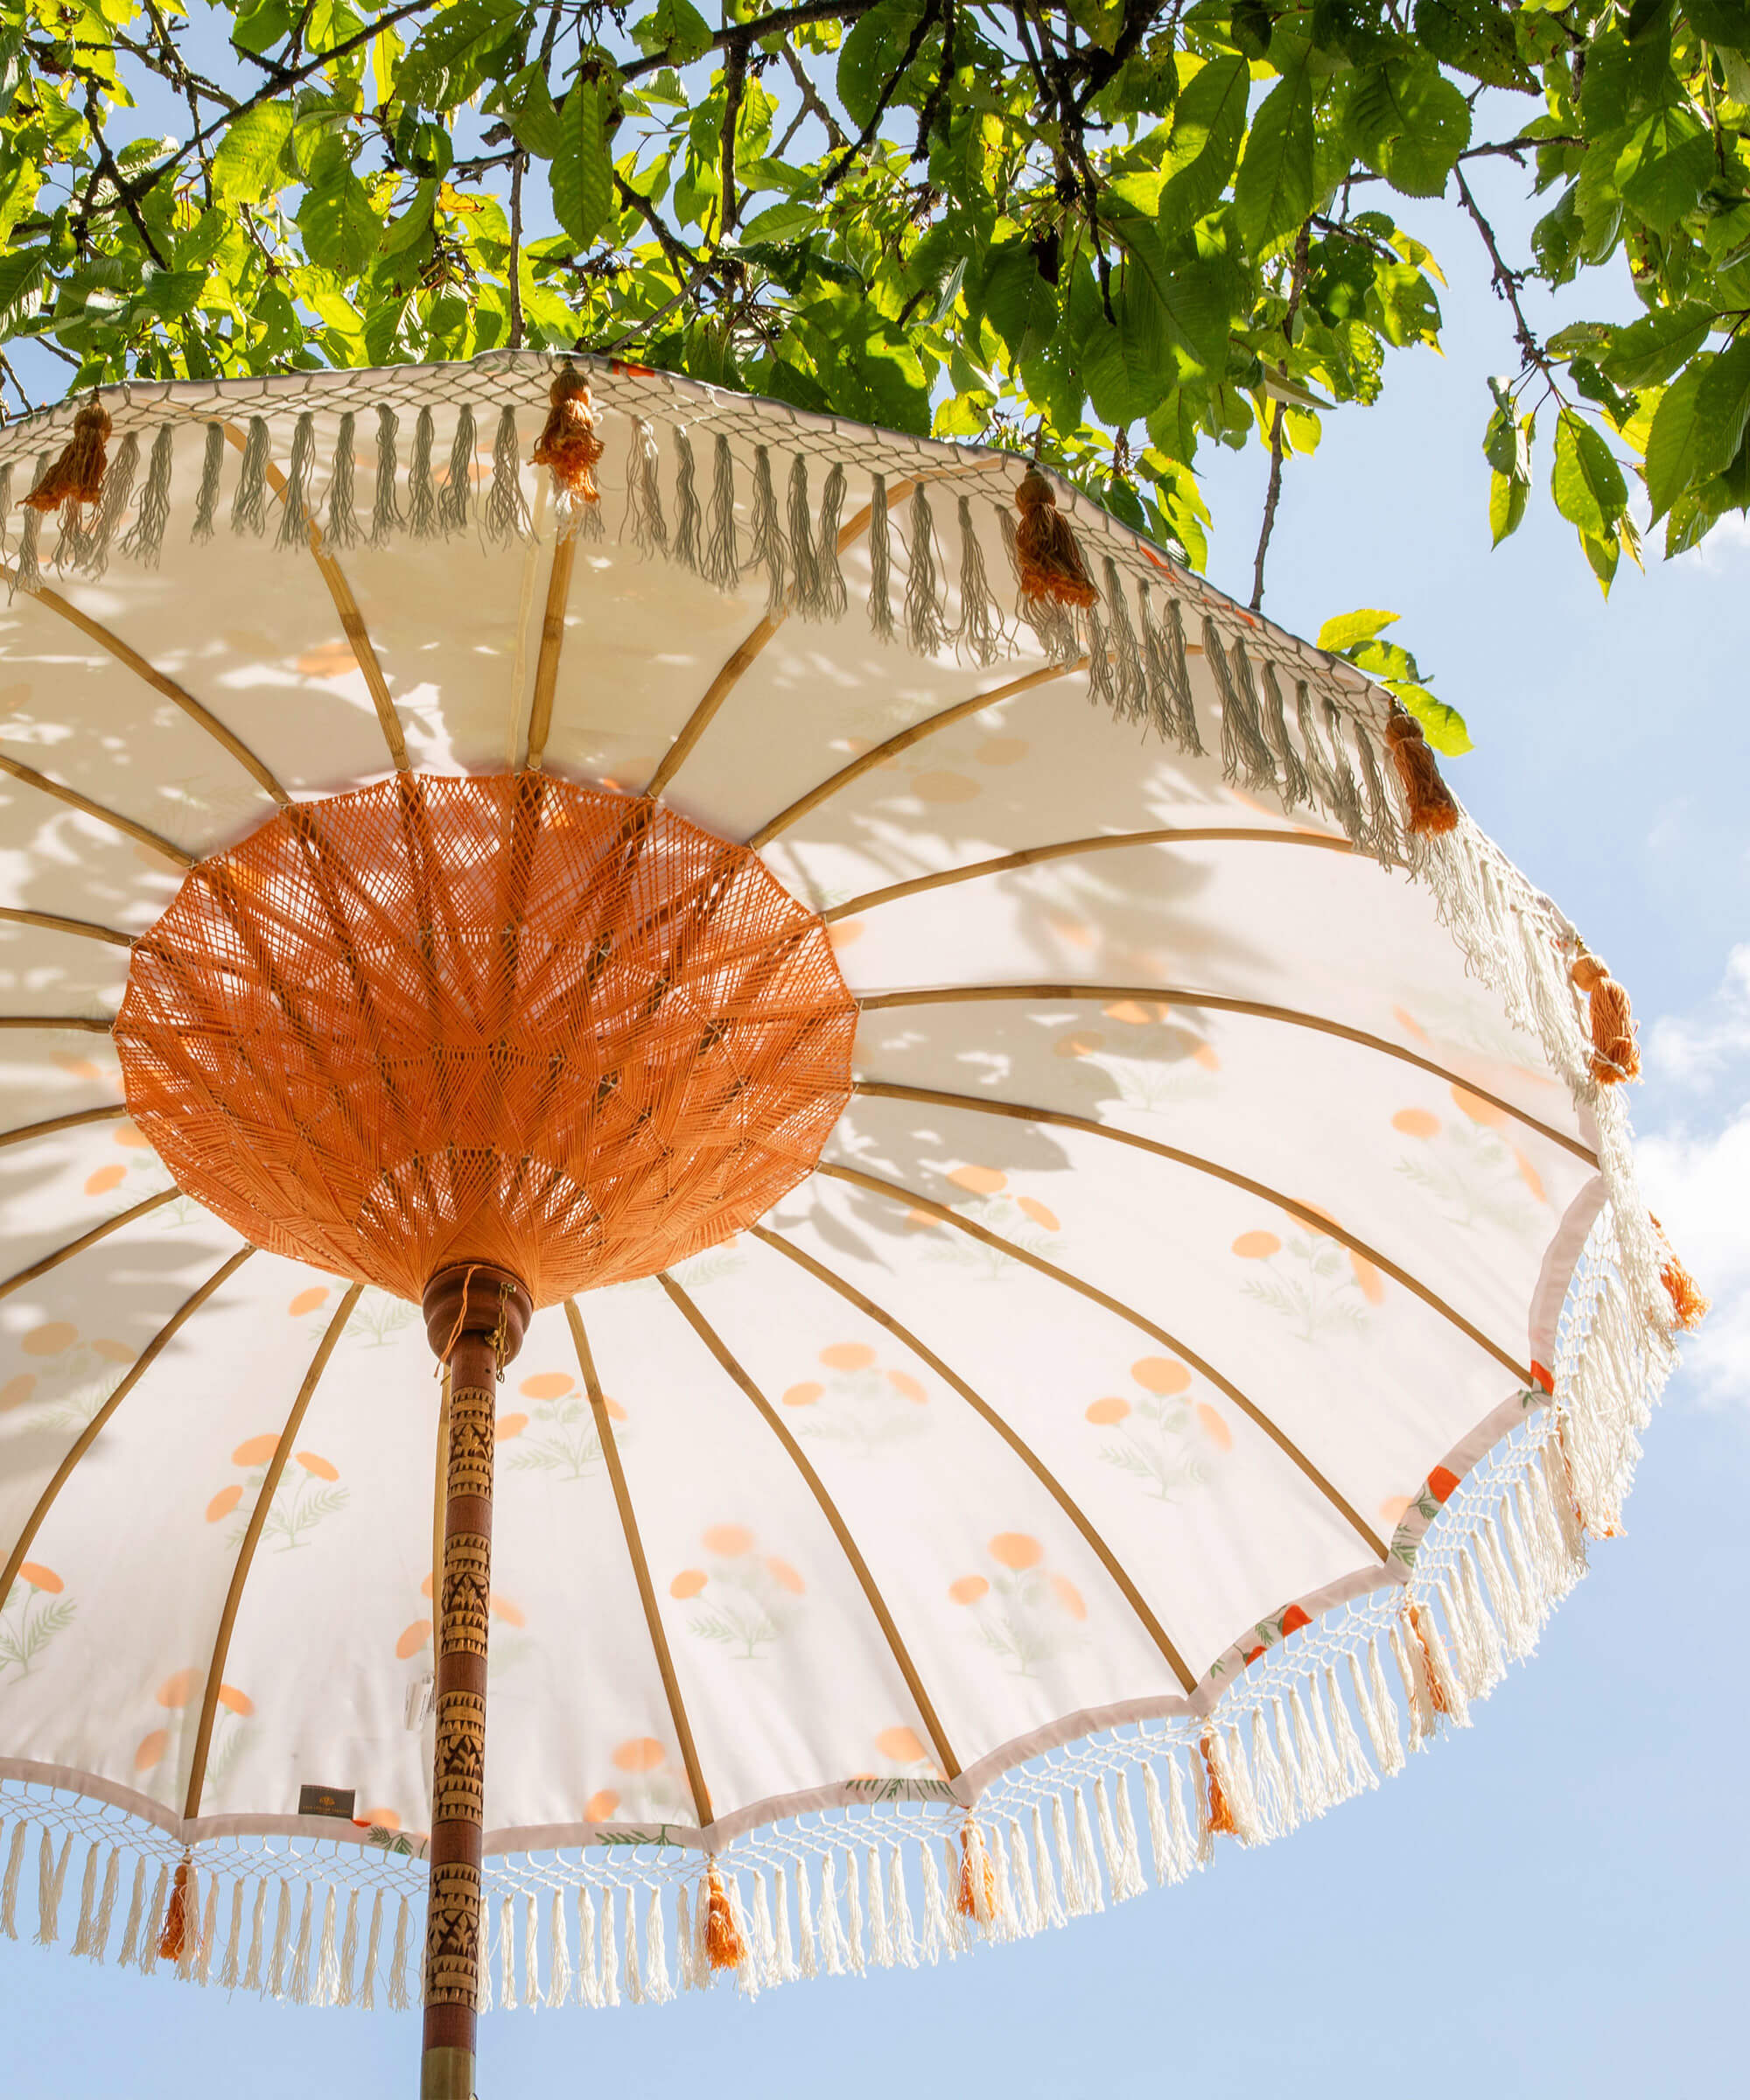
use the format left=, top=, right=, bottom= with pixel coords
left=1634, top=943, right=1750, bottom=1407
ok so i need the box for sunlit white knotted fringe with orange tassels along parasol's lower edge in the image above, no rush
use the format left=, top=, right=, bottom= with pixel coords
left=0, top=1386, right=1633, bottom=2010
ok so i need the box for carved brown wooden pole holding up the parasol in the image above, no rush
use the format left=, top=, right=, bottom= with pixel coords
left=420, top=1264, right=531, bottom=2100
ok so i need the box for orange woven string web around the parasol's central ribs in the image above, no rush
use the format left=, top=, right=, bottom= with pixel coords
left=116, top=773, right=858, bottom=1304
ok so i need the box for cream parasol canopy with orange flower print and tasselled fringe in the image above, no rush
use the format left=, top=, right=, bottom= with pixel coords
left=0, top=355, right=1672, bottom=2004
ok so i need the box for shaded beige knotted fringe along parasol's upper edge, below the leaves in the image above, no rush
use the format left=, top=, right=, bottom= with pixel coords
left=0, top=371, right=1397, bottom=789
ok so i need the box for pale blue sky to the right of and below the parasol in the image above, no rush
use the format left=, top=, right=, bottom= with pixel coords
left=0, top=66, right=1750, bottom=2100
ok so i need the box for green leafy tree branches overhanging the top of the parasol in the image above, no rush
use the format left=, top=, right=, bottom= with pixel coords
left=0, top=0, right=1750, bottom=600
